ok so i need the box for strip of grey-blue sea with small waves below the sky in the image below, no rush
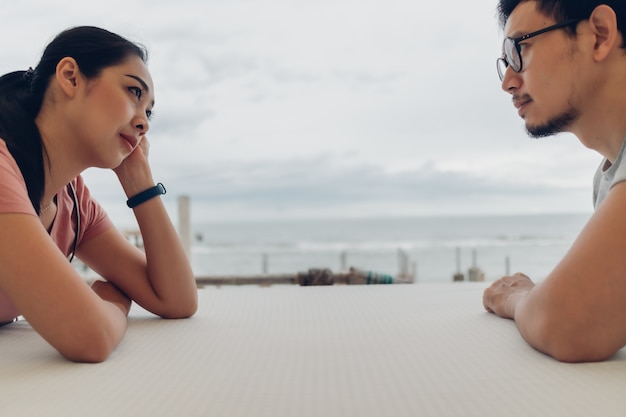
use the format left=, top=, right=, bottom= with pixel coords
left=186, top=214, right=590, bottom=282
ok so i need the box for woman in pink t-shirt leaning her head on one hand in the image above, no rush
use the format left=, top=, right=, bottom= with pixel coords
left=0, top=27, right=197, bottom=362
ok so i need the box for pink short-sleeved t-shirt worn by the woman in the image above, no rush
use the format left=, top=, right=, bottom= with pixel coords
left=0, top=139, right=113, bottom=323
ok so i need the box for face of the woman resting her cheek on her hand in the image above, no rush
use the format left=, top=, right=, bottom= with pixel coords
left=73, top=56, right=154, bottom=168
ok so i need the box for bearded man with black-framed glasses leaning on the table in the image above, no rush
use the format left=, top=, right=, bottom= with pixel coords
left=483, top=0, right=626, bottom=362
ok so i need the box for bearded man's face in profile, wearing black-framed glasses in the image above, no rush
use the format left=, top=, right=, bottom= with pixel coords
left=502, top=1, right=579, bottom=137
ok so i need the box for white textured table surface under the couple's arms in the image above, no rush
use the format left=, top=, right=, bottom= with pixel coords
left=0, top=283, right=626, bottom=417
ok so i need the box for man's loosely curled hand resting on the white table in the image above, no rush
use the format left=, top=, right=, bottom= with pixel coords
left=483, top=272, right=535, bottom=319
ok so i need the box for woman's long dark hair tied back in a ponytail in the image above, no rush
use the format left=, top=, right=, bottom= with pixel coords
left=0, top=26, right=147, bottom=214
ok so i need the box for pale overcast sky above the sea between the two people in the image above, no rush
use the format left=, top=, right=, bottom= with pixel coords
left=0, top=0, right=600, bottom=225
